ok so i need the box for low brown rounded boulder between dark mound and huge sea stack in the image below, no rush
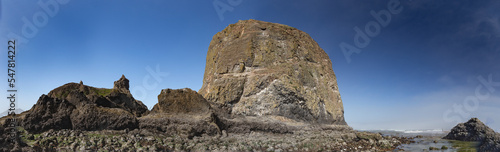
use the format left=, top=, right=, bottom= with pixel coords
left=139, top=88, right=220, bottom=138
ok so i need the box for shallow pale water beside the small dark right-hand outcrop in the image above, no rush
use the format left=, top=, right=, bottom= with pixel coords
left=364, top=129, right=464, bottom=152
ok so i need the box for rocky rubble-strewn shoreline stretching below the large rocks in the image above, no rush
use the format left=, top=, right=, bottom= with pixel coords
left=6, top=127, right=412, bottom=152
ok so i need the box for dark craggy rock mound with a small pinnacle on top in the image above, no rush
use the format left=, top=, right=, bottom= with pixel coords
left=22, top=76, right=148, bottom=133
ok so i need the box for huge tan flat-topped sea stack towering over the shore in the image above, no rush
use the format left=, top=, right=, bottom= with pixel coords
left=199, top=20, right=346, bottom=124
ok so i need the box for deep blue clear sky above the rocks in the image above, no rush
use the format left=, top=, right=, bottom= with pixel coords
left=0, top=0, right=500, bottom=131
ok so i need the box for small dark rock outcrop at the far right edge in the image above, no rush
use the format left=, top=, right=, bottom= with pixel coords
left=443, top=118, right=500, bottom=151
